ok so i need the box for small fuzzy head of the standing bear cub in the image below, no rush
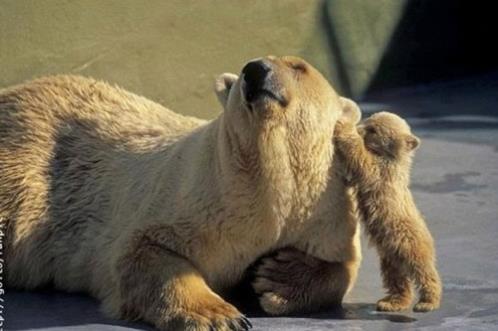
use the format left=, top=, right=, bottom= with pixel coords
left=358, top=112, right=420, bottom=159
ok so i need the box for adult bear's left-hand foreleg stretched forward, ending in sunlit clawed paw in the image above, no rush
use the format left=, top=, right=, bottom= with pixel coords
left=103, top=232, right=250, bottom=331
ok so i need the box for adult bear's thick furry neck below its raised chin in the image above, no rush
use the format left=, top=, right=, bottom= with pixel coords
left=217, top=118, right=333, bottom=235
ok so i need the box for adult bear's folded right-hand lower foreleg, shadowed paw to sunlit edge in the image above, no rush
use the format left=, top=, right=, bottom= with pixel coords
left=253, top=248, right=359, bottom=315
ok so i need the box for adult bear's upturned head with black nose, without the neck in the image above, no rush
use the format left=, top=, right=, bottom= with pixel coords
left=215, top=56, right=353, bottom=165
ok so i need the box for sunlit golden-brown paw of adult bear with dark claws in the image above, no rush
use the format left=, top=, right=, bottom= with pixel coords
left=158, top=299, right=252, bottom=331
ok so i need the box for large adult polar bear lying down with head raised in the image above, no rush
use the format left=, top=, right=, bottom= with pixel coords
left=0, top=57, right=360, bottom=330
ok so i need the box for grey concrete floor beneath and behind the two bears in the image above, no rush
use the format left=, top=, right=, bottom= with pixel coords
left=4, top=74, right=498, bottom=331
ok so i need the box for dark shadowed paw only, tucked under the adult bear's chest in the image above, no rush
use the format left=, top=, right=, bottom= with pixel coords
left=252, top=248, right=313, bottom=315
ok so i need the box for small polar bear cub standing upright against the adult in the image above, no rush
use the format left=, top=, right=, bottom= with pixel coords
left=335, top=112, right=441, bottom=311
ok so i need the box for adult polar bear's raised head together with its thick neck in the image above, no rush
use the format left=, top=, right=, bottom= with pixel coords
left=215, top=56, right=360, bottom=220
